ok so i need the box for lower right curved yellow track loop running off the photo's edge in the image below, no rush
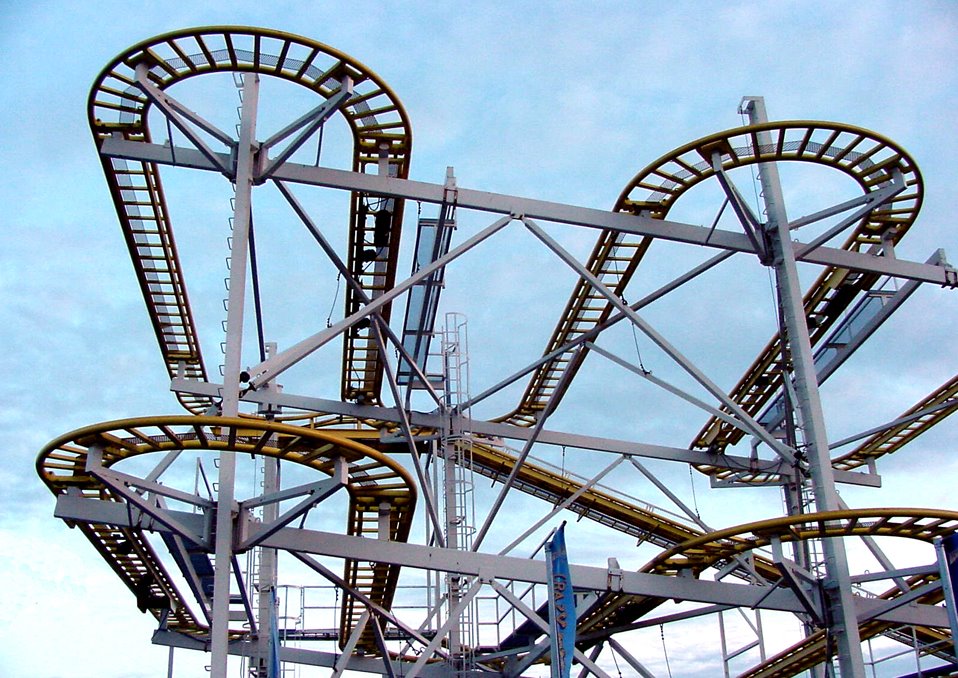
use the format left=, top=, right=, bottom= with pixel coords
left=578, top=508, right=958, bottom=660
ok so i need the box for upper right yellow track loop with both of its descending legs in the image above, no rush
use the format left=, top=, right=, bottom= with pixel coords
left=502, top=121, right=923, bottom=470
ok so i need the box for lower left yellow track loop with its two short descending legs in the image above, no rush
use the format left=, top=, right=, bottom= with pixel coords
left=37, top=415, right=416, bottom=651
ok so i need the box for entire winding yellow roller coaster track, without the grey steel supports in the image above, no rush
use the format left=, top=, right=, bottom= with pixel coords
left=37, top=27, right=958, bottom=676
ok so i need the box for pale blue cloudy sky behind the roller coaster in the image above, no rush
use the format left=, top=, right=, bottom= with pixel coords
left=0, top=2, right=958, bottom=678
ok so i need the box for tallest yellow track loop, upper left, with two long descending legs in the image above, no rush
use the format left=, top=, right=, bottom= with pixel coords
left=88, top=26, right=412, bottom=414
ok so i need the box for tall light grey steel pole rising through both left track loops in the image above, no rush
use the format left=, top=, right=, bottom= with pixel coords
left=210, top=73, right=259, bottom=678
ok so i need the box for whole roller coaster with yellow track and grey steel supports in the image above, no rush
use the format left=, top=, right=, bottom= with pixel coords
left=37, top=27, right=958, bottom=677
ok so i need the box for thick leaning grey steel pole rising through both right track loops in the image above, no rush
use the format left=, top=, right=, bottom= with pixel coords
left=742, top=97, right=865, bottom=678
